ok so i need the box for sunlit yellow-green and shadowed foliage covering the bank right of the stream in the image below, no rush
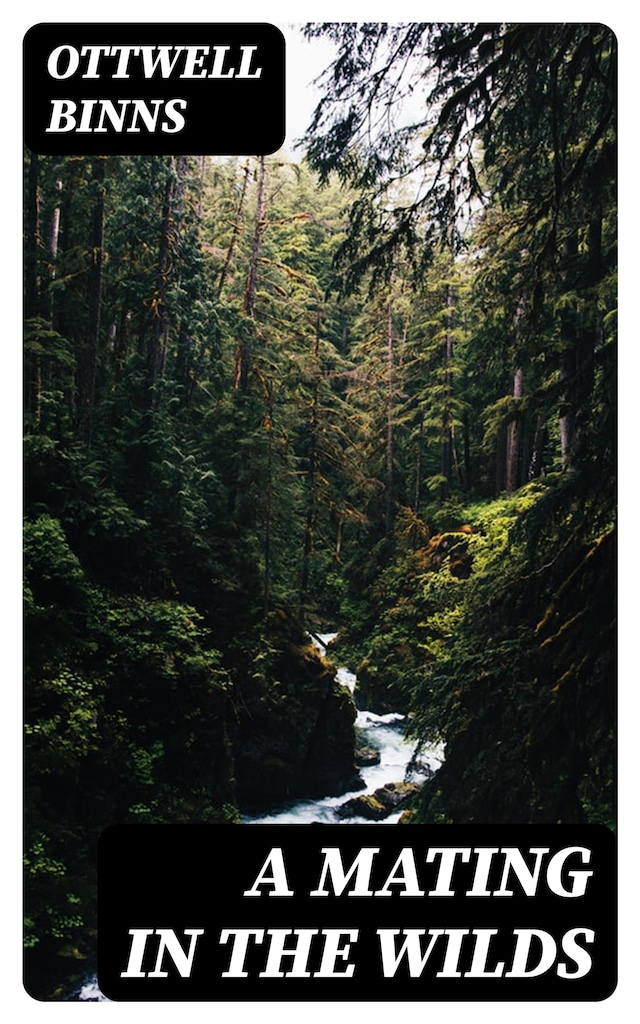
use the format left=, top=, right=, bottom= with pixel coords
left=329, top=480, right=615, bottom=826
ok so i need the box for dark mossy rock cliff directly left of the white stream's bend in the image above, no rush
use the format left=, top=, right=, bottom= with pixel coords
left=229, top=612, right=358, bottom=812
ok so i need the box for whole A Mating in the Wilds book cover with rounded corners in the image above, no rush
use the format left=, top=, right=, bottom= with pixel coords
left=14, top=4, right=618, bottom=1012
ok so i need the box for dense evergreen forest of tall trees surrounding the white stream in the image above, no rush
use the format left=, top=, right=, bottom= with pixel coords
left=24, top=23, right=616, bottom=998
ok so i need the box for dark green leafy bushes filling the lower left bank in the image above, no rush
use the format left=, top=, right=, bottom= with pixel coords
left=25, top=515, right=237, bottom=974
